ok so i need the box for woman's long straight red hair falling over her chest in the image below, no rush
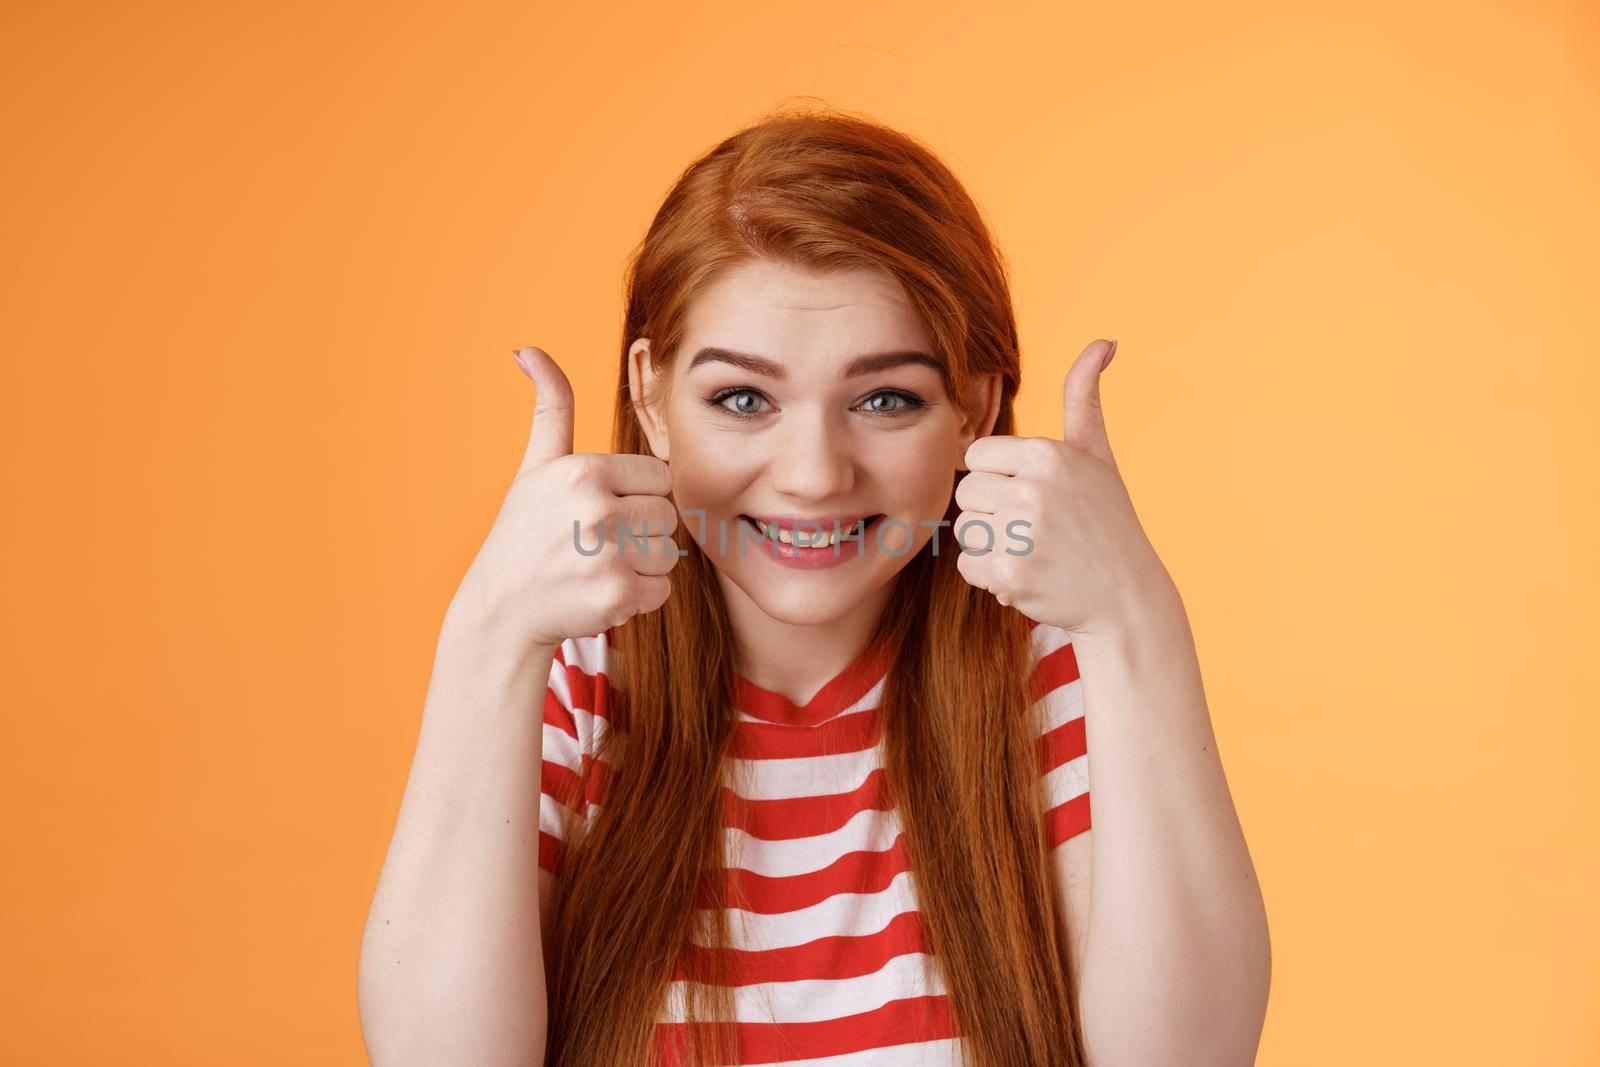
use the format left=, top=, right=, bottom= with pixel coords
left=546, top=102, right=1083, bottom=1067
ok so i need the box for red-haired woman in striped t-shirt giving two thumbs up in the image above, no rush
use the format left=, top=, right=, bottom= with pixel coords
left=360, top=102, right=1269, bottom=1067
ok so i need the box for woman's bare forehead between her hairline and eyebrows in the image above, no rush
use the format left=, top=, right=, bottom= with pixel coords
left=680, top=261, right=930, bottom=366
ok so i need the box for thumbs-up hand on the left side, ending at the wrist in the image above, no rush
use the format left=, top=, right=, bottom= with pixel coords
left=453, top=347, right=678, bottom=649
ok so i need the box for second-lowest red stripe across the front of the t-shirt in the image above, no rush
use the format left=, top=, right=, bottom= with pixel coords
left=672, top=912, right=931, bottom=985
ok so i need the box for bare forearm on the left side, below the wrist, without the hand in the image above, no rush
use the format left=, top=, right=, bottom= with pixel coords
left=358, top=601, right=554, bottom=1067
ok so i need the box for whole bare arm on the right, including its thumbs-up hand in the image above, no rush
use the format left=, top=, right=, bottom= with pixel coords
left=955, top=341, right=1270, bottom=1067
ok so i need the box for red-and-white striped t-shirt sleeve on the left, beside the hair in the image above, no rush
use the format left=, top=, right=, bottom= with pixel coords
left=539, top=633, right=611, bottom=875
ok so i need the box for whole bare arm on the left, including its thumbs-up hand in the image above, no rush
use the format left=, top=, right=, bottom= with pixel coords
left=358, top=349, right=678, bottom=1067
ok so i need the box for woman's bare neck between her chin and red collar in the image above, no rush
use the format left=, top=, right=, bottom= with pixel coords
left=717, top=573, right=894, bottom=704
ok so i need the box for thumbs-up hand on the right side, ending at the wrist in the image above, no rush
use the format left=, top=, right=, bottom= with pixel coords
left=955, top=341, right=1171, bottom=633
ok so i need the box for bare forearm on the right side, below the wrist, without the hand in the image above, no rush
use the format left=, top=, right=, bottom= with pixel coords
left=1072, top=584, right=1270, bottom=1067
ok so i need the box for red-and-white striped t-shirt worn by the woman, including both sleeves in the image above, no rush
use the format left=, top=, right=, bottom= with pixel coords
left=539, top=624, right=1090, bottom=1067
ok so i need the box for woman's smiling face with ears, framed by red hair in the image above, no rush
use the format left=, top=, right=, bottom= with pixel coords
left=630, top=261, right=998, bottom=625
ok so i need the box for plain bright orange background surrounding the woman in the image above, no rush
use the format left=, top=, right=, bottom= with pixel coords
left=0, top=0, right=1600, bottom=1067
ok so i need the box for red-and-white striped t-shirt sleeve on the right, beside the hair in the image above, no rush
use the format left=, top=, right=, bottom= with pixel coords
left=1030, top=622, right=1090, bottom=848
